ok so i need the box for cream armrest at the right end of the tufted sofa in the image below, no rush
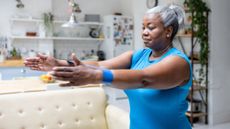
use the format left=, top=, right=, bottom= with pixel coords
left=105, top=105, right=129, bottom=129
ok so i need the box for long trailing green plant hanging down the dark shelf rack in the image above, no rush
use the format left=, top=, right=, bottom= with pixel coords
left=187, top=0, right=210, bottom=83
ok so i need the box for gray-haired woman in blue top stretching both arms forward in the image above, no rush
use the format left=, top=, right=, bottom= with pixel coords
left=25, top=5, right=192, bottom=129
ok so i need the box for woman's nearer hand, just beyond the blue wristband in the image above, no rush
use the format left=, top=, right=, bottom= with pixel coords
left=51, top=65, right=102, bottom=86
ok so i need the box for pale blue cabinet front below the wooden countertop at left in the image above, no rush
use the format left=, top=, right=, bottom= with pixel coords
left=0, top=67, right=46, bottom=80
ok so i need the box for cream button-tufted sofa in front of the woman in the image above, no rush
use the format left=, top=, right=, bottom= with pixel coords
left=0, top=87, right=129, bottom=129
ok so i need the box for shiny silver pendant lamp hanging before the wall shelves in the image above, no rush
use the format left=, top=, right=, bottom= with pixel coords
left=62, top=0, right=81, bottom=28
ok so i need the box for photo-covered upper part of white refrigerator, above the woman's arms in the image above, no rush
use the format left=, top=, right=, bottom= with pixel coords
left=102, top=15, right=134, bottom=59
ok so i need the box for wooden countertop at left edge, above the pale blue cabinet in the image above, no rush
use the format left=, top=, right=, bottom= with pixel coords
left=0, top=60, right=25, bottom=67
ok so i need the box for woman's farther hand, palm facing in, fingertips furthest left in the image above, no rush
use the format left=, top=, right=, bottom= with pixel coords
left=24, top=54, right=58, bottom=71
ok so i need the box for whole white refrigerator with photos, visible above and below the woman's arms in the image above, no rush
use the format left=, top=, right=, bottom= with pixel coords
left=102, top=15, right=134, bottom=108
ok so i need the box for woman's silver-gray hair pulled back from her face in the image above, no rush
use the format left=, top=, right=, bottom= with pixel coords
left=146, top=4, right=185, bottom=40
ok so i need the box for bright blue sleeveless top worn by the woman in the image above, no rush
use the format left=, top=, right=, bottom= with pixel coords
left=125, top=48, right=192, bottom=129
